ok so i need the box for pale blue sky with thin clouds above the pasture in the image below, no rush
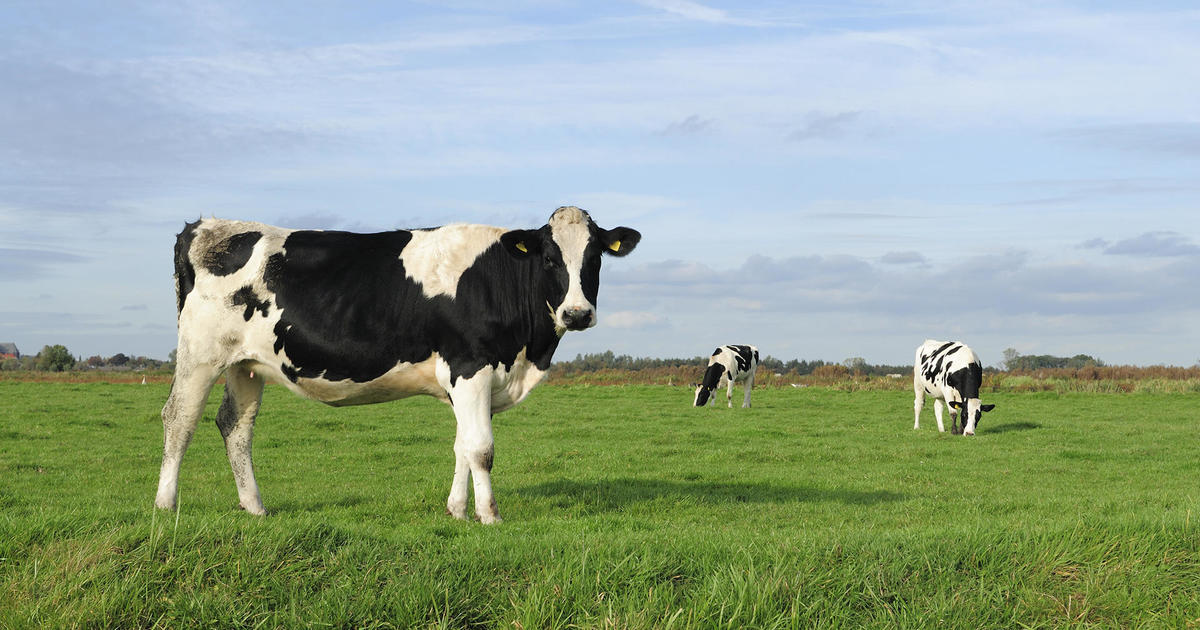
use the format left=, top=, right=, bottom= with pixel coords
left=0, top=0, right=1200, bottom=365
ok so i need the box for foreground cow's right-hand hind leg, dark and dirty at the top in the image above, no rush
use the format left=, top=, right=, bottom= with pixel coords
left=217, top=365, right=266, bottom=516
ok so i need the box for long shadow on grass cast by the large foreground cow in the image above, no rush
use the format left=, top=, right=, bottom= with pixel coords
left=515, top=478, right=907, bottom=511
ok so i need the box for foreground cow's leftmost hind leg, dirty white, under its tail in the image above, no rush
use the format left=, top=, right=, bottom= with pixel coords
left=154, top=360, right=221, bottom=510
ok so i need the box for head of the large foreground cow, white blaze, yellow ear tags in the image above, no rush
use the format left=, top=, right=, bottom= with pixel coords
left=500, top=205, right=642, bottom=335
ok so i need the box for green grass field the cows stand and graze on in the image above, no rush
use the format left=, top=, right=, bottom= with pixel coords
left=0, top=382, right=1200, bottom=629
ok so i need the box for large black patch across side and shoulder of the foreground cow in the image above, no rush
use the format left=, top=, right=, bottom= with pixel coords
left=265, top=229, right=571, bottom=383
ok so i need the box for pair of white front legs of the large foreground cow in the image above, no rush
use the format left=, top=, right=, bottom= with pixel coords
left=446, top=367, right=500, bottom=524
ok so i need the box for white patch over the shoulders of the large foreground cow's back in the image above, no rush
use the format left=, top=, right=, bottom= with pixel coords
left=400, top=223, right=505, bottom=298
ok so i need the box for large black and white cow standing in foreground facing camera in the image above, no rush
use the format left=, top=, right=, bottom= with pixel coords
left=155, top=206, right=641, bottom=523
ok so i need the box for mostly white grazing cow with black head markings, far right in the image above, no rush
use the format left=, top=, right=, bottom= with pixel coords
left=912, top=340, right=996, bottom=436
